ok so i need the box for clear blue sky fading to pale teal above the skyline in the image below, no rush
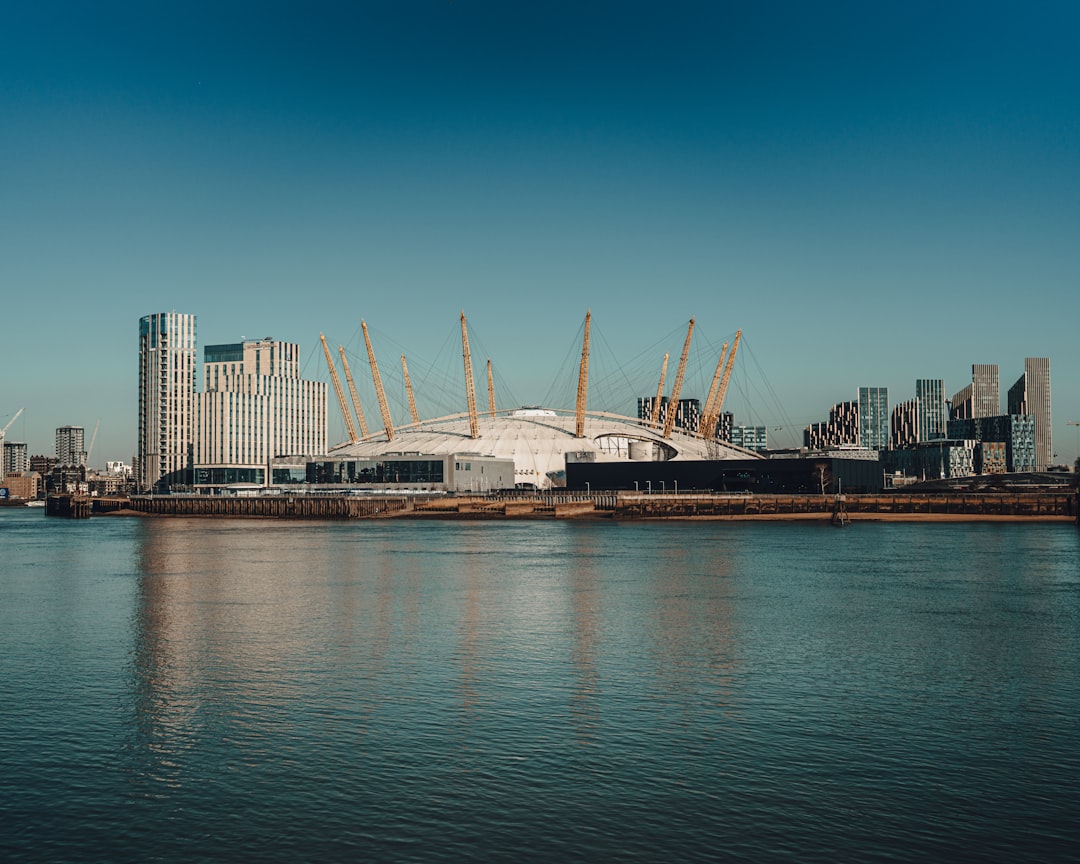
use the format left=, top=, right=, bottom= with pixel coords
left=0, top=0, right=1080, bottom=463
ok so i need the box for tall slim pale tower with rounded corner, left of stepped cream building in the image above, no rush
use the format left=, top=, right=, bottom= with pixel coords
left=137, top=312, right=195, bottom=489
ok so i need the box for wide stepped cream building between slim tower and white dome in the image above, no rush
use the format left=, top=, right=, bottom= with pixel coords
left=194, top=338, right=326, bottom=486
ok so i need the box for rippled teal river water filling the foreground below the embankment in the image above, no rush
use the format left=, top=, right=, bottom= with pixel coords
left=0, top=509, right=1080, bottom=862
